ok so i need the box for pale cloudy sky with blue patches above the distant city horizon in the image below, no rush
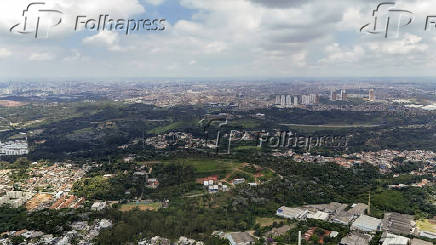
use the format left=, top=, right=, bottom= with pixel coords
left=0, top=0, right=436, bottom=79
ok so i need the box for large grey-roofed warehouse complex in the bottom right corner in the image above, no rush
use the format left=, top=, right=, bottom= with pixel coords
left=276, top=202, right=436, bottom=245
